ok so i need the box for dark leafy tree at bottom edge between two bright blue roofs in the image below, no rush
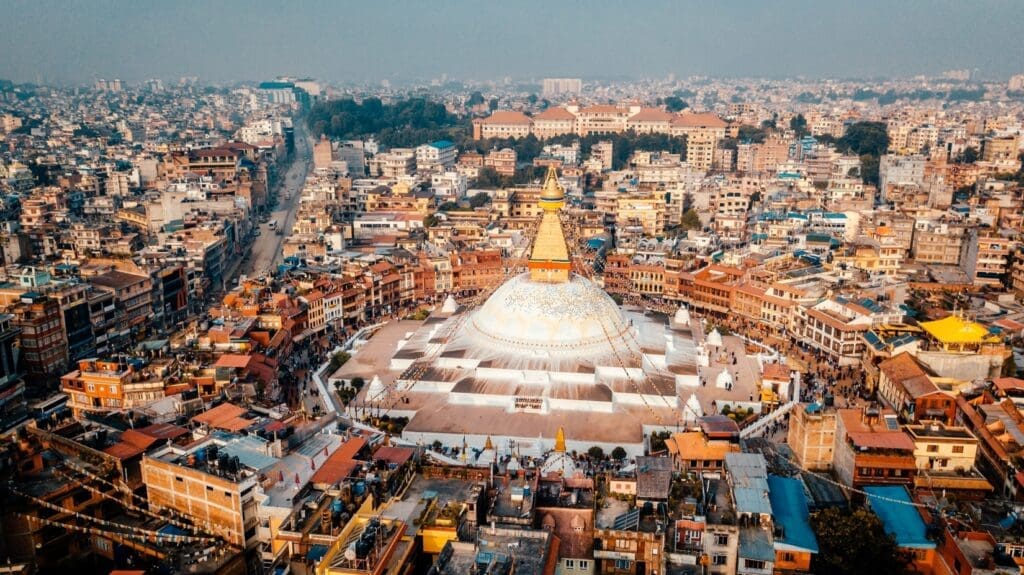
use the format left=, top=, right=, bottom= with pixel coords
left=811, top=507, right=909, bottom=575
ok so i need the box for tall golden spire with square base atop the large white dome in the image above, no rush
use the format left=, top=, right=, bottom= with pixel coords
left=529, top=166, right=571, bottom=283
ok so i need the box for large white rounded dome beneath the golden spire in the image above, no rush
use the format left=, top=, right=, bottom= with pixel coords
left=464, top=273, right=635, bottom=358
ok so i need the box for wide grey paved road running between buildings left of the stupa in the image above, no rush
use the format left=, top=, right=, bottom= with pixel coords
left=240, top=120, right=312, bottom=277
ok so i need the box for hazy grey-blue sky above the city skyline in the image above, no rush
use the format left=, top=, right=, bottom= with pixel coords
left=0, top=0, right=1024, bottom=83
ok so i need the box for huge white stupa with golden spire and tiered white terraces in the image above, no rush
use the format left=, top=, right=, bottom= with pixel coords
left=380, top=169, right=699, bottom=457
